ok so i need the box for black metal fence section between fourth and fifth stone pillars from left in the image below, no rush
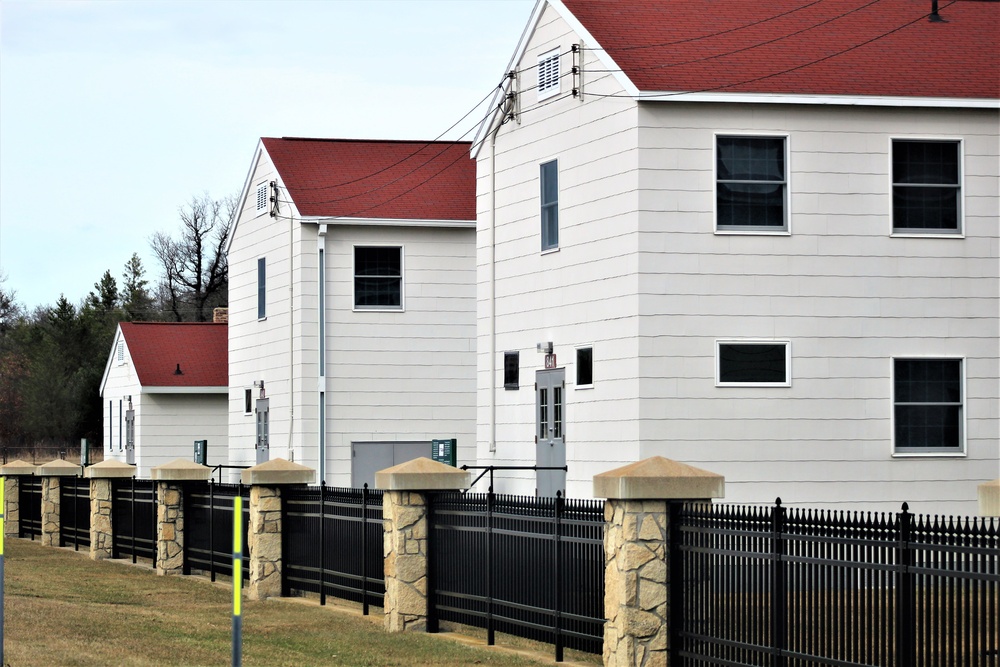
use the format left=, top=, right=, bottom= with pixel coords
left=184, top=480, right=250, bottom=581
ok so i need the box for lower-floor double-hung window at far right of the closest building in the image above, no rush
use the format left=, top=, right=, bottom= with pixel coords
left=892, top=357, right=965, bottom=455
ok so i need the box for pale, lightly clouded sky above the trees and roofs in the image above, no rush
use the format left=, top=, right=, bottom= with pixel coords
left=0, top=0, right=534, bottom=310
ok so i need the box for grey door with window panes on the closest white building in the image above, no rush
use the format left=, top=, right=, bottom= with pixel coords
left=535, top=368, right=566, bottom=497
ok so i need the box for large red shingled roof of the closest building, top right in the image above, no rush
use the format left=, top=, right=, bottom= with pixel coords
left=563, top=0, right=1000, bottom=99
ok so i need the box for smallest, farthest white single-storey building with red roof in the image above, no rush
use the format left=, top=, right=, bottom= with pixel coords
left=101, top=322, right=229, bottom=479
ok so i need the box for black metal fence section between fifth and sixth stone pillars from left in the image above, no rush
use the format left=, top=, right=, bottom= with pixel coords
left=282, top=484, right=385, bottom=614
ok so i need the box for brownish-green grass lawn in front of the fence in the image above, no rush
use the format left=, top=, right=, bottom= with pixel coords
left=4, top=538, right=584, bottom=667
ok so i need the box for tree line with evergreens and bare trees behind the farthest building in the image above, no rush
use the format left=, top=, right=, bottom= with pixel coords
left=0, top=194, right=237, bottom=449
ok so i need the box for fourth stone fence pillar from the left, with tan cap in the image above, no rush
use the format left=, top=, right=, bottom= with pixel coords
left=150, top=459, right=212, bottom=575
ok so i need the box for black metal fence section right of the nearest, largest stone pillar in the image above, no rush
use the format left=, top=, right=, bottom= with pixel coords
left=669, top=499, right=1000, bottom=667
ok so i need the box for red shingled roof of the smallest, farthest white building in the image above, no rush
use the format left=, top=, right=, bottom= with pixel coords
left=119, top=322, right=229, bottom=387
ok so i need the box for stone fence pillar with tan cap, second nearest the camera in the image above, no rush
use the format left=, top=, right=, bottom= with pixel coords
left=375, top=458, right=472, bottom=632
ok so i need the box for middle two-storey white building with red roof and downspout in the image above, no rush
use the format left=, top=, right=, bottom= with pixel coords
left=227, top=138, right=476, bottom=486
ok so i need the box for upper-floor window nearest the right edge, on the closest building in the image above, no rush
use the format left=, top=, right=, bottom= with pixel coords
left=892, top=138, right=962, bottom=235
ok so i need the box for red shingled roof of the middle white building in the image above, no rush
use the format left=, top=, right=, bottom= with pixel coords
left=261, top=138, right=476, bottom=221
